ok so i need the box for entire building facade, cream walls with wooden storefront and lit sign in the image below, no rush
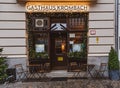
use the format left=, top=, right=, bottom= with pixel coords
left=0, top=0, right=116, bottom=70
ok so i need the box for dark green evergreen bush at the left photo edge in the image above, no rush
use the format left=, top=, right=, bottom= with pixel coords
left=0, top=48, right=8, bottom=83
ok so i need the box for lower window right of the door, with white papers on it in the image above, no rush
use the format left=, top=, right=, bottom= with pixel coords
left=69, top=32, right=87, bottom=57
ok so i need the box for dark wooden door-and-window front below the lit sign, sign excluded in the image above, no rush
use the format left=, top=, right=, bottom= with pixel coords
left=26, top=13, right=88, bottom=69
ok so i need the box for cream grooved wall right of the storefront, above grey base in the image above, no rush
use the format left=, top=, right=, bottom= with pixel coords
left=88, top=0, right=115, bottom=56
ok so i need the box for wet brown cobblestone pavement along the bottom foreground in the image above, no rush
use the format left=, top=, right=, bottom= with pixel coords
left=0, top=79, right=120, bottom=88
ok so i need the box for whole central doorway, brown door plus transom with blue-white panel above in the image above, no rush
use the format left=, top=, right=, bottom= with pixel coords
left=50, top=13, right=67, bottom=70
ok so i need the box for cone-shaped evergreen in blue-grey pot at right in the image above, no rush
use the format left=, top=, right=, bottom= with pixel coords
left=108, top=47, right=120, bottom=80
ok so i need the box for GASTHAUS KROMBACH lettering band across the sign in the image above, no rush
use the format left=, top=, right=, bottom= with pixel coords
left=26, top=4, right=88, bottom=12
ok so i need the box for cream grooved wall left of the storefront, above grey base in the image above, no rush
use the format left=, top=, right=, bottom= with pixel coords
left=0, top=0, right=27, bottom=58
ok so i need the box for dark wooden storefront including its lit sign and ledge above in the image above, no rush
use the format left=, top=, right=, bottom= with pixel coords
left=17, top=0, right=96, bottom=70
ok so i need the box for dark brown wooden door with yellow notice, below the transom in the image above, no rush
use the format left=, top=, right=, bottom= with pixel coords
left=50, top=31, right=67, bottom=70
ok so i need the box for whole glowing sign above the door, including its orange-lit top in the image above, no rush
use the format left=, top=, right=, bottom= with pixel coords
left=26, top=2, right=89, bottom=13
